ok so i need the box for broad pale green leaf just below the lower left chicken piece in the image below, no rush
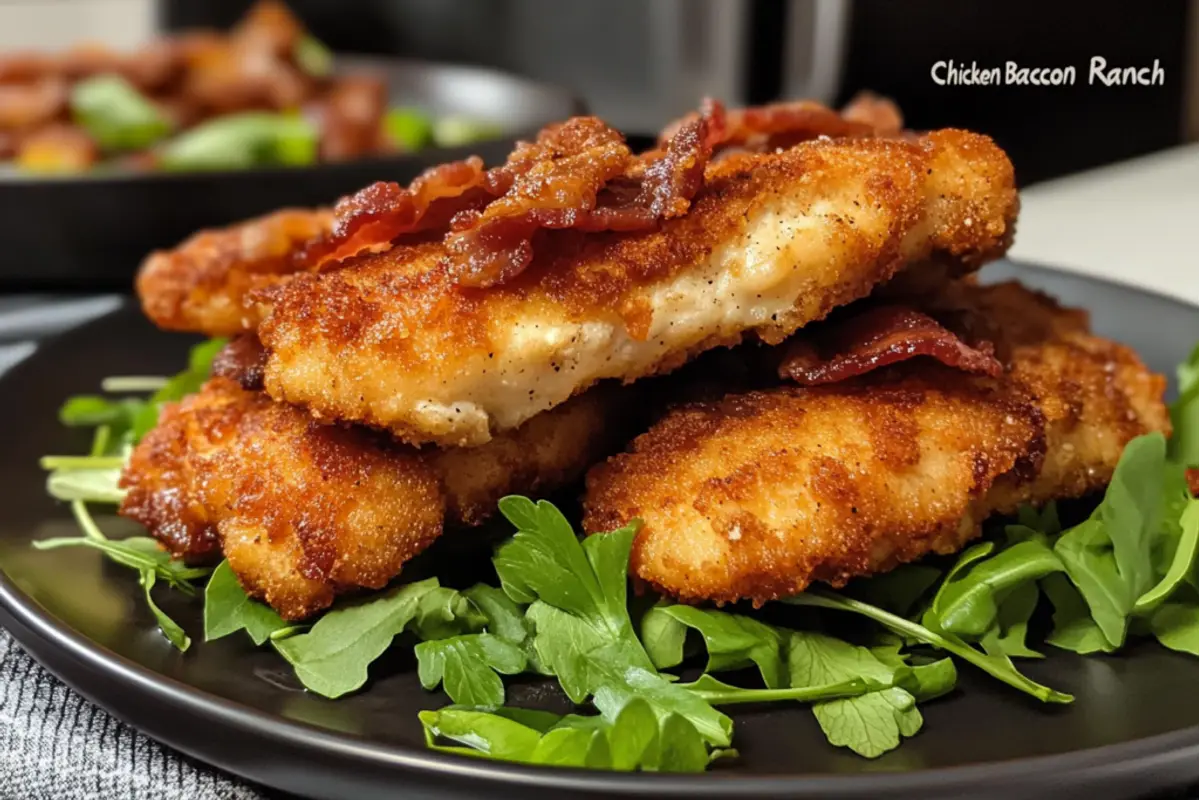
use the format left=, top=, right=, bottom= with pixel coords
left=271, top=578, right=438, bottom=698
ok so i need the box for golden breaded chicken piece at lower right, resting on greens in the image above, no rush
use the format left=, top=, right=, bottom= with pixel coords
left=584, top=284, right=1170, bottom=603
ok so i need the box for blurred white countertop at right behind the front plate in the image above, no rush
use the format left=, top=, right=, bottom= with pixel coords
left=1009, top=143, right=1200, bottom=306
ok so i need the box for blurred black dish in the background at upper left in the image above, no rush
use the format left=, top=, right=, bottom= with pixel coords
left=0, top=58, right=581, bottom=289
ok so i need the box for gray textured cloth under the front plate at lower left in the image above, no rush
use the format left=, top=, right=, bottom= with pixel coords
left=0, top=630, right=266, bottom=800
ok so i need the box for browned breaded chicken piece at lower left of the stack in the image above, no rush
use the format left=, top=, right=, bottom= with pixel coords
left=121, top=378, right=624, bottom=619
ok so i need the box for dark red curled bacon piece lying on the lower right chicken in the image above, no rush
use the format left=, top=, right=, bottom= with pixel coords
left=779, top=306, right=1004, bottom=386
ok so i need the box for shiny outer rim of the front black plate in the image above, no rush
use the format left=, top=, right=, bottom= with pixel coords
left=0, top=259, right=1200, bottom=798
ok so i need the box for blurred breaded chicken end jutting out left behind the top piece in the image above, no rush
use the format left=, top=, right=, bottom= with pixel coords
left=137, top=209, right=332, bottom=336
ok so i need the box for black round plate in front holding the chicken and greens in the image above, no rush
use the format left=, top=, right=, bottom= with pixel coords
left=0, top=265, right=1200, bottom=799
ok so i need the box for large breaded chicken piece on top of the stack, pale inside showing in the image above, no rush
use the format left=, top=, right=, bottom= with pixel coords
left=259, top=131, right=1016, bottom=445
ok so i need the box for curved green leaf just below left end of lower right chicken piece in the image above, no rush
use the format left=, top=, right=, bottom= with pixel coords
left=642, top=606, right=788, bottom=688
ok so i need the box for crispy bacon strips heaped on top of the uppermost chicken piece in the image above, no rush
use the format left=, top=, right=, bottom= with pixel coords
left=298, top=101, right=725, bottom=288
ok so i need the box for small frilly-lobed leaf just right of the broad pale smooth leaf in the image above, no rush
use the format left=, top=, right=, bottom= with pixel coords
left=415, top=633, right=526, bottom=708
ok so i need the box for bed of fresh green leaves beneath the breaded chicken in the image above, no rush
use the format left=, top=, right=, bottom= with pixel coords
left=34, top=341, right=1200, bottom=771
